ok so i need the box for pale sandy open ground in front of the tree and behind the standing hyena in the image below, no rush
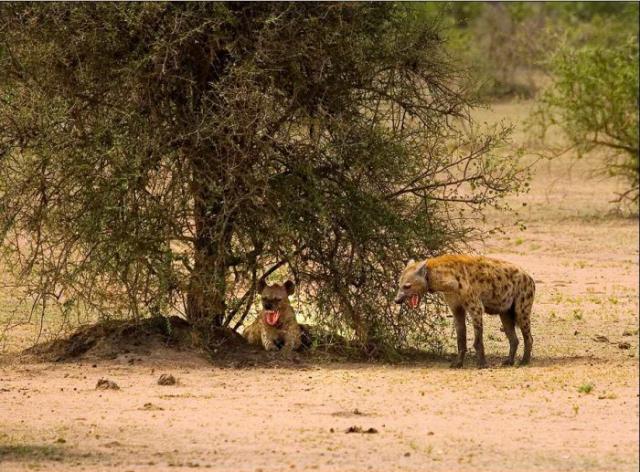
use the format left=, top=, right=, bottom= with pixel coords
left=0, top=104, right=639, bottom=472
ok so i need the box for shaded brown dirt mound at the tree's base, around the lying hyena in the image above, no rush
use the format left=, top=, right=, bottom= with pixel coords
left=18, top=316, right=357, bottom=367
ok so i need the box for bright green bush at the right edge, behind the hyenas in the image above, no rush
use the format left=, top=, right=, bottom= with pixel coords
left=537, top=35, right=639, bottom=202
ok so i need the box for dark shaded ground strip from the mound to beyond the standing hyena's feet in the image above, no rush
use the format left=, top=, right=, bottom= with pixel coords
left=13, top=317, right=607, bottom=370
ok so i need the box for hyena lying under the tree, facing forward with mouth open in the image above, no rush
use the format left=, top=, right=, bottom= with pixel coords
left=244, top=280, right=302, bottom=353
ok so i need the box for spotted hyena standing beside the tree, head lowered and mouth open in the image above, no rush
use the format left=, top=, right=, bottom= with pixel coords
left=395, top=255, right=536, bottom=368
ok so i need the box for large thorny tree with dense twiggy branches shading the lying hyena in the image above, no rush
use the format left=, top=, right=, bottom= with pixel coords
left=0, top=3, right=523, bottom=345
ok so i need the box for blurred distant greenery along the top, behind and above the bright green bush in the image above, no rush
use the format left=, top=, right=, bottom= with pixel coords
left=422, top=2, right=638, bottom=99
